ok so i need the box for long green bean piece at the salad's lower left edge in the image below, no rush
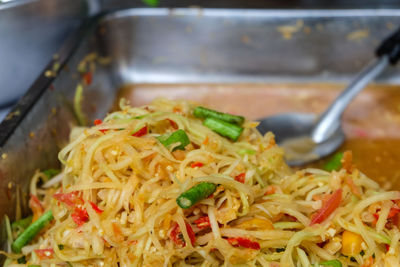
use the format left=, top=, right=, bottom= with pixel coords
left=11, top=211, right=54, bottom=253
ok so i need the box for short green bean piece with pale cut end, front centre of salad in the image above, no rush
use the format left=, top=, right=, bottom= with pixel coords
left=176, top=182, right=217, bottom=209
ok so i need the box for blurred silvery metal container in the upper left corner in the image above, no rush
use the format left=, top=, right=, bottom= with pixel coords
left=0, top=0, right=90, bottom=107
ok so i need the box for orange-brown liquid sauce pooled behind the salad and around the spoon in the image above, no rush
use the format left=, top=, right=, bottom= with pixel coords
left=119, top=83, right=400, bottom=189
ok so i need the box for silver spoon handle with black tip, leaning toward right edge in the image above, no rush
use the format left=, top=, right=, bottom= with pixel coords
left=311, top=28, right=400, bottom=143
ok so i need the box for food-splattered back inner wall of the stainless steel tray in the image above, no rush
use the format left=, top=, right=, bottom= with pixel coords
left=104, top=9, right=400, bottom=83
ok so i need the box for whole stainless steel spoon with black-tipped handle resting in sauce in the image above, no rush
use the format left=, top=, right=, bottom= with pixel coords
left=257, top=29, right=400, bottom=166
